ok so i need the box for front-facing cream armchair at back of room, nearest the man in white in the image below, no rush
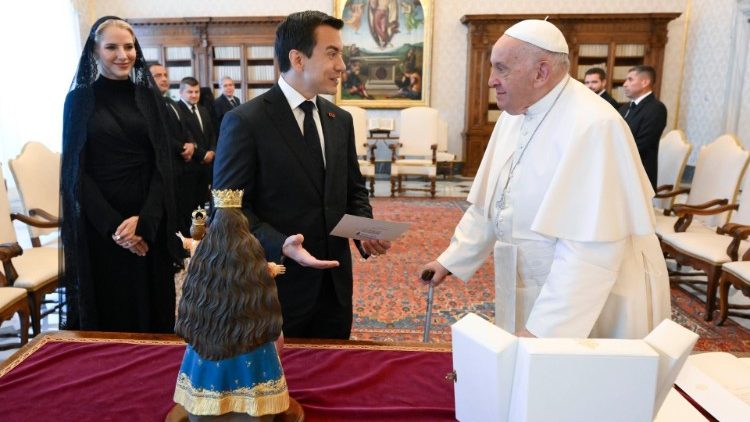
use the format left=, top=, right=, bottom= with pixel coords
left=388, top=107, right=439, bottom=198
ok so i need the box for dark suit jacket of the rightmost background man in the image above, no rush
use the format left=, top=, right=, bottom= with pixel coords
left=620, top=93, right=667, bottom=189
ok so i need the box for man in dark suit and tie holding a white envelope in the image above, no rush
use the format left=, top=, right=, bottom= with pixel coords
left=214, top=11, right=390, bottom=339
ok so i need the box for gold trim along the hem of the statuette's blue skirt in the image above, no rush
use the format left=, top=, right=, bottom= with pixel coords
left=174, top=373, right=289, bottom=416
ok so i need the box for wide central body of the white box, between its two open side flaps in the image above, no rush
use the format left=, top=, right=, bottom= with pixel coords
left=512, top=338, right=659, bottom=422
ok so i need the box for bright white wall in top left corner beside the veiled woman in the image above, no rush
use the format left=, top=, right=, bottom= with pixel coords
left=0, top=0, right=81, bottom=186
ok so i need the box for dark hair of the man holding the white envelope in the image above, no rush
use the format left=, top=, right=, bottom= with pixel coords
left=273, top=10, right=344, bottom=73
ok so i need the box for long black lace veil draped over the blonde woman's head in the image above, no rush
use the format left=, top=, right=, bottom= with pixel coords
left=58, top=16, right=182, bottom=329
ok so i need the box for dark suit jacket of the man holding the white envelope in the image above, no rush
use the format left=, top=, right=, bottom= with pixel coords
left=214, top=85, right=372, bottom=318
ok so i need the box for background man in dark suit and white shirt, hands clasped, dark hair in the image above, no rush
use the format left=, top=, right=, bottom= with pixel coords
left=177, top=76, right=216, bottom=221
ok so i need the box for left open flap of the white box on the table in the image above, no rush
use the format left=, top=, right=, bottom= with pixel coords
left=451, top=313, right=518, bottom=422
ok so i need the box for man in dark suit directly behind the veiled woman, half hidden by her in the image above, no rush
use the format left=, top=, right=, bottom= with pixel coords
left=149, top=63, right=195, bottom=236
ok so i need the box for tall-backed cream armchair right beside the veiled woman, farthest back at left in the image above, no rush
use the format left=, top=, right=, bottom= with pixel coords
left=8, top=142, right=60, bottom=247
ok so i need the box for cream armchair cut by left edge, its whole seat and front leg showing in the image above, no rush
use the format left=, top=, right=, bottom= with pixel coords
left=0, top=165, right=59, bottom=335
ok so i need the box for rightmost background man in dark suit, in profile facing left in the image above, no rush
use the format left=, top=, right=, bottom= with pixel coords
left=620, top=65, right=667, bottom=190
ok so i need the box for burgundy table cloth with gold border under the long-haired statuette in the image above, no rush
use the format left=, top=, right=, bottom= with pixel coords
left=0, top=332, right=455, bottom=422
